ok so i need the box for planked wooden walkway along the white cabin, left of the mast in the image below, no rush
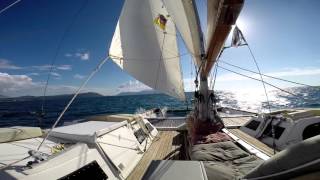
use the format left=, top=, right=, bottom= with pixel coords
left=127, top=131, right=181, bottom=180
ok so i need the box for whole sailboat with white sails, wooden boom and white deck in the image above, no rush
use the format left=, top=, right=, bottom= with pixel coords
left=0, top=0, right=320, bottom=180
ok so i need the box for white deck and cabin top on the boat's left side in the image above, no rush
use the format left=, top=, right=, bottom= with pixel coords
left=0, top=116, right=157, bottom=180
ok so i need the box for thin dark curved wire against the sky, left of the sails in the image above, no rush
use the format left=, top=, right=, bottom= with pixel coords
left=41, top=0, right=88, bottom=119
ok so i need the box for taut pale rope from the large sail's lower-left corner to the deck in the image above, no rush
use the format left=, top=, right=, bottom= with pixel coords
left=37, top=56, right=109, bottom=150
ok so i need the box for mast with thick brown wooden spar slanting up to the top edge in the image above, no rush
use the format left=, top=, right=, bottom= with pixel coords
left=196, top=0, right=244, bottom=126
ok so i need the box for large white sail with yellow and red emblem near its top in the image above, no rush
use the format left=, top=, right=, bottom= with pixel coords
left=109, top=0, right=185, bottom=100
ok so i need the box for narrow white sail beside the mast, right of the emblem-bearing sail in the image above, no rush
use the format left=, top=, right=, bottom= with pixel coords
left=163, top=0, right=204, bottom=67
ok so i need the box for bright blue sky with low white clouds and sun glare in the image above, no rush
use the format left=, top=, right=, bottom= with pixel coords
left=0, top=0, right=320, bottom=96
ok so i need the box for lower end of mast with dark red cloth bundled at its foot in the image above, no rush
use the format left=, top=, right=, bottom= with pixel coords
left=194, top=77, right=224, bottom=134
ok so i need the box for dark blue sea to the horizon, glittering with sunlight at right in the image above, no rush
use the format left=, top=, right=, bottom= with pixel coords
left=0, top=87, right=320, bottom=128
